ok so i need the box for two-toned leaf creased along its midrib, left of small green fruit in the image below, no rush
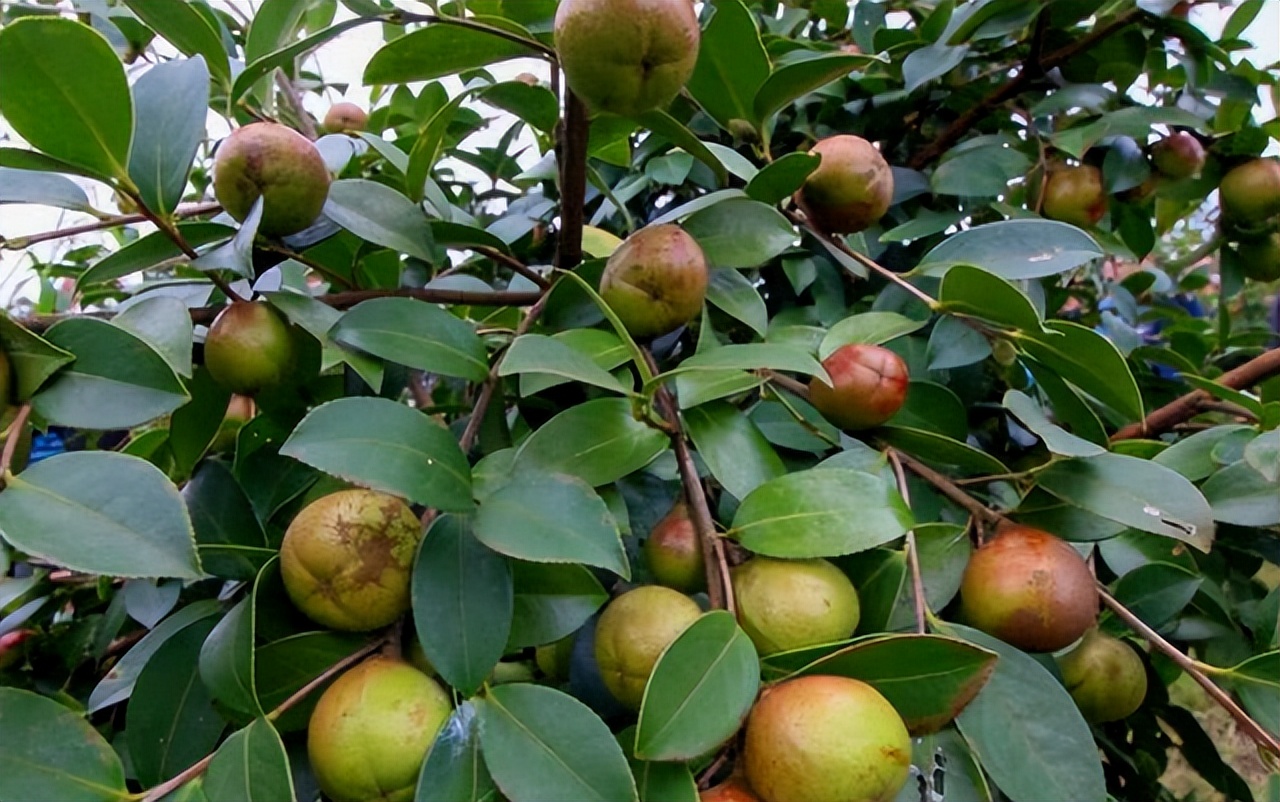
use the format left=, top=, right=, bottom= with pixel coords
left=32, top=317, right=191, bottom=429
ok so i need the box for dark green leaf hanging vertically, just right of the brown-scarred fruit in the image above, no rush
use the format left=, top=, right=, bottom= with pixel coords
left=412, top=515, right=513, bottom=696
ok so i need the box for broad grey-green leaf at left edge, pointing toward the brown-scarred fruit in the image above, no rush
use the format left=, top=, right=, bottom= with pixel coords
left=0, top=452, right=201, bottom=579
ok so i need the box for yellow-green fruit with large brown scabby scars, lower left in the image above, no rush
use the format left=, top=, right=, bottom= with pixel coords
left=280, top=490, right=422, bottom=632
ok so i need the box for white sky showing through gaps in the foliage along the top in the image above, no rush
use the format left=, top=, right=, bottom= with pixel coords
left=0, top=0, right=1280, bottom=306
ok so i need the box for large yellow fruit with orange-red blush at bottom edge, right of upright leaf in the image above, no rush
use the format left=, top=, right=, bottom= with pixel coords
left=744, top=675, right=911, bottom=802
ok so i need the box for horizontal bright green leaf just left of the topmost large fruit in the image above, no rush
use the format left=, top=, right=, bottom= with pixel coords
left=364, top=24, right=538, bottom=86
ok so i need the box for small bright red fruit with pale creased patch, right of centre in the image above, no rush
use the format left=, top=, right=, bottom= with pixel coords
left=809, top=344, right=910, bottom=431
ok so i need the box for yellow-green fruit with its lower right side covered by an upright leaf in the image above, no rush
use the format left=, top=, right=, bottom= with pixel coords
left=595, top=585, right=703, bottom=710
